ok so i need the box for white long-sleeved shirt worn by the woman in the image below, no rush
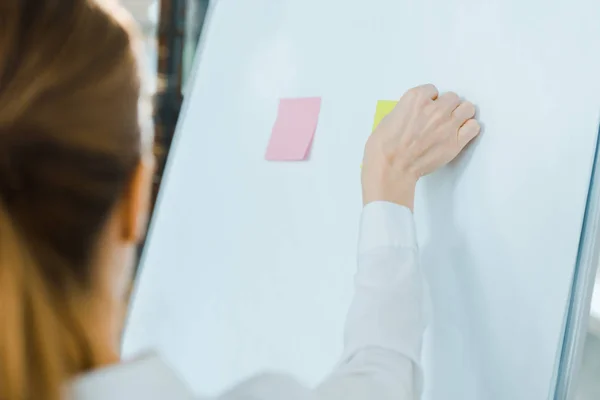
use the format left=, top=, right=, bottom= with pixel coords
left=69, top=202, right=426, bottom=400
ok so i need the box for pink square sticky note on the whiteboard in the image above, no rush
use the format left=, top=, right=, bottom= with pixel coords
left=265, top=97, right=321, bottom=161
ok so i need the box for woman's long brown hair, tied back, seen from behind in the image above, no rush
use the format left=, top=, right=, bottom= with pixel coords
left=0, top=0, right=148, bottom=400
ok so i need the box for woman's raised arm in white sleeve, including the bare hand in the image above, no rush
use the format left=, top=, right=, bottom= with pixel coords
left=317, top=85, right=480, bottom=400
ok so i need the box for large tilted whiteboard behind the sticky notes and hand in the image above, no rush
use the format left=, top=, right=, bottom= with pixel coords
left=124, top=0, right=600, bottom=400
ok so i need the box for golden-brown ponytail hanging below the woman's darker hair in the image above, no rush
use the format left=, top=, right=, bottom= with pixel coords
left=0, top=201, right=94, bottom=400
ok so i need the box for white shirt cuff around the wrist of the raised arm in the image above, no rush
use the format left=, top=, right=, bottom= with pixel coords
left=358, top=201, right=418, bottom=254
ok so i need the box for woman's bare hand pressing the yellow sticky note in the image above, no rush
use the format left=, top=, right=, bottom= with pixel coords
left=362, top=85, right=480, bottom=210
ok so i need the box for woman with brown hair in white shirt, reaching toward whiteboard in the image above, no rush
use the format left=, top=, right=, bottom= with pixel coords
left=0, top=0, right=479, bottom=400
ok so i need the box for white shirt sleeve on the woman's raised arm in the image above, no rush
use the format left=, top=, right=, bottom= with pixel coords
left=221, top=202, right=426, bottom=400
